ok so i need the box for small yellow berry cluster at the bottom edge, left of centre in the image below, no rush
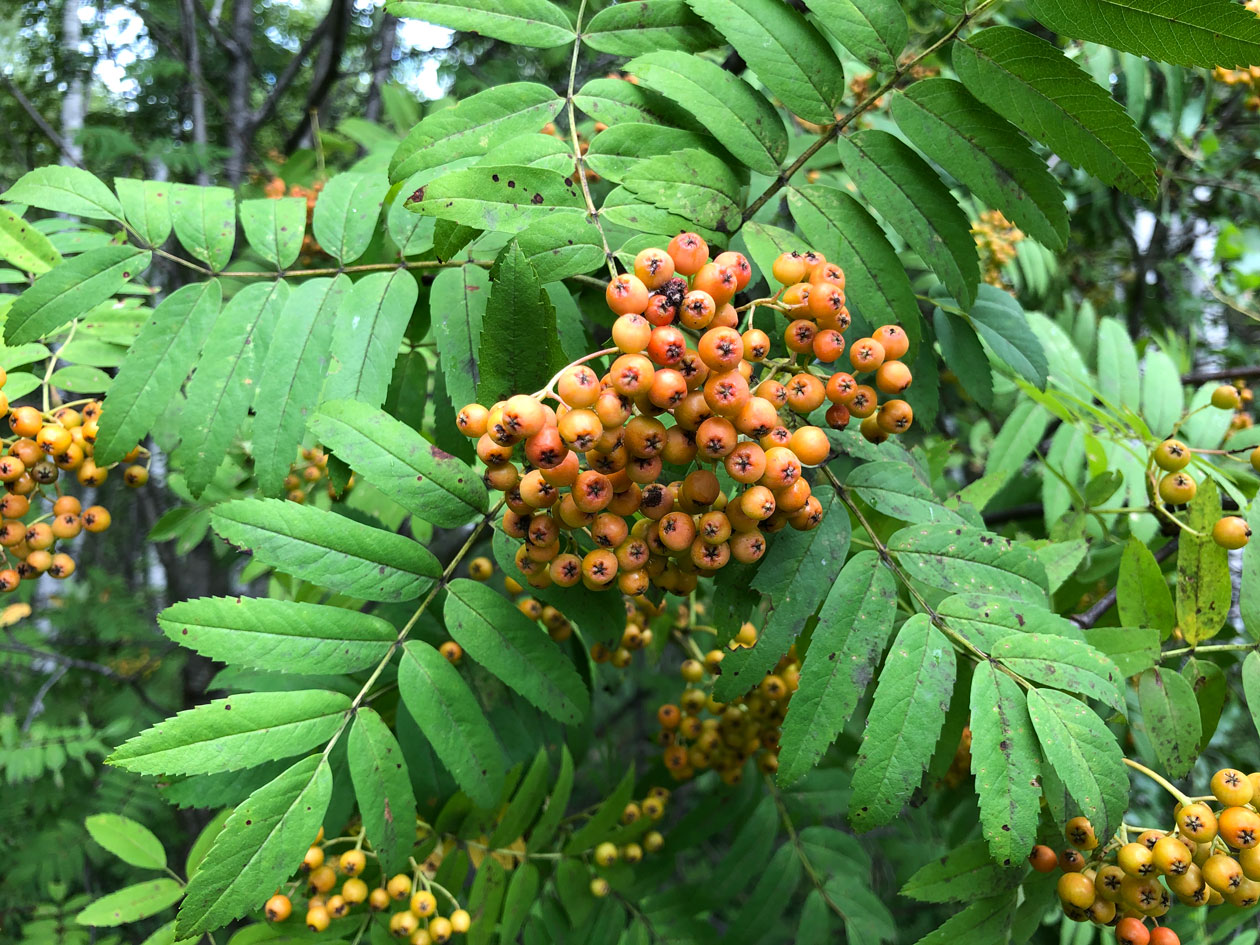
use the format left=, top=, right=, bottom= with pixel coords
left=263, top=830, right=473, bottom=945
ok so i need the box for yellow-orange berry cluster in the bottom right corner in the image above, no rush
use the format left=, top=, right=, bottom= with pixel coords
left=1028, top=767, right=1260, bottom=945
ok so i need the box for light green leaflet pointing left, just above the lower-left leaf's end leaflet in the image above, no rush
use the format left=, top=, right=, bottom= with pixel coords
left=106, top=689, right=350, bottom=775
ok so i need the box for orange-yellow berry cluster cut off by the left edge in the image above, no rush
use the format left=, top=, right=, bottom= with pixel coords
left=0, top=385, right=139, bottom=592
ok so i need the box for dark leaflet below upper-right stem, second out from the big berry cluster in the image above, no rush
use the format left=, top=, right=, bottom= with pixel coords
left=837, top=130, right=980, bottom=309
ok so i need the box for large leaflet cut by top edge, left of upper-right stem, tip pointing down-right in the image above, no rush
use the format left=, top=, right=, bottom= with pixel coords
left=688, top=0, right=847, bottom=125
